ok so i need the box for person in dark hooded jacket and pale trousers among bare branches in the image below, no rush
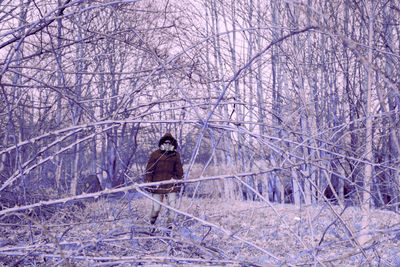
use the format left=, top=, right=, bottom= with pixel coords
left=146, top=133, right=183, bottom=228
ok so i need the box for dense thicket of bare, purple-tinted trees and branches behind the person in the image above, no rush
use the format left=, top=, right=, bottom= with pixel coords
left=0, top=0, right=400, bottom=266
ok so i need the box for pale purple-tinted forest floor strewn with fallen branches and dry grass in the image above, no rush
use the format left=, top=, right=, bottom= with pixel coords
left=0, top=195, right=400, bottom=266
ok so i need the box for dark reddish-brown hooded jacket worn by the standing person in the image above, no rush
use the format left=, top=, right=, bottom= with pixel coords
left=146, top=133, right=183, bottom=194
